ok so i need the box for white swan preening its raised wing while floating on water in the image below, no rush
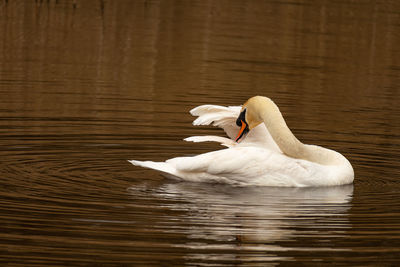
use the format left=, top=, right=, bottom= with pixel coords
left=129, top=96, right=354, bottom=187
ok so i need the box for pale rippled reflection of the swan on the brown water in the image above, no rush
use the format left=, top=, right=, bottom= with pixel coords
left=130, top=183, right=353, bottom=260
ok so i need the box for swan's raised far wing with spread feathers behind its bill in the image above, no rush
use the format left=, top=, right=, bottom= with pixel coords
left=189, top=105, right=281, bottom=152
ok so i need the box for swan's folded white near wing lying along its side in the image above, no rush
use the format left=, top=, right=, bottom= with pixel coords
left=165, top=146, right=318, bottom=187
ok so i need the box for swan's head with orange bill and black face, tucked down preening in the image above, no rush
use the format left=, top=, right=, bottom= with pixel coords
left=236, top=96, right=269, bottom=142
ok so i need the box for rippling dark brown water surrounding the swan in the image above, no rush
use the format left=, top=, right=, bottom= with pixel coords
left=0, top=0, right=400, bottom=266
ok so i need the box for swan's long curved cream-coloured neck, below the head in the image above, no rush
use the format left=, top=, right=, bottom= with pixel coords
left=258, top=99, right=338, bottom=164
